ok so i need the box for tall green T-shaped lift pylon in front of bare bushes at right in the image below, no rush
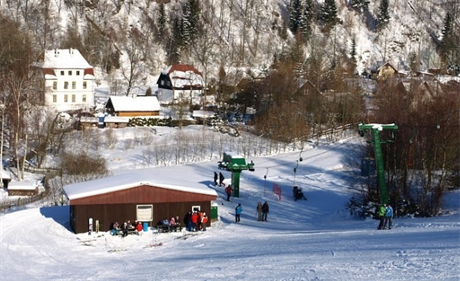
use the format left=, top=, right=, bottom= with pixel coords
left=358, top=123, right=398, bottom=204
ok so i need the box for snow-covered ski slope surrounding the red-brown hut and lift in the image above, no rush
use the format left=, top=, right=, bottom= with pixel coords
left=0, top=126, right=460, bottom=281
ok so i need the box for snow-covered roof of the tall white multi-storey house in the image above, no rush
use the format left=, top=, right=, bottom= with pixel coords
left=42, top=49, right=92, bottom=68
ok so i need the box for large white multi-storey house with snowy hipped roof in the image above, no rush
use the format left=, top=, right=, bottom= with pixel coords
left=35, top=49, right=95, bottom=112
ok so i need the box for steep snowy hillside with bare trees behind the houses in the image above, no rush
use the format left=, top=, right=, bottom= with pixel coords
left=0, top=0, right=458, bottom=88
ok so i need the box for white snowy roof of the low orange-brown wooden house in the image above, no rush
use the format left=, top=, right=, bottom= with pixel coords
left=110, top=96, right=161, bottom=111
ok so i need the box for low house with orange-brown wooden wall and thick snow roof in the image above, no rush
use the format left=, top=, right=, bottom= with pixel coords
left=105, top=95, right=160, bottom=117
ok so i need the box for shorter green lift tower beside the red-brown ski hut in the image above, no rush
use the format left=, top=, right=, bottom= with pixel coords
left=218, top=152, right=254, bottom=197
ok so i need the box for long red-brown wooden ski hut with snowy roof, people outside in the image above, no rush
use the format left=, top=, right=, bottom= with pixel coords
left=64, top=168, right=217, bottom=233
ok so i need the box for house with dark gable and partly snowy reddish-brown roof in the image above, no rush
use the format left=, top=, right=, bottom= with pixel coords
left=156, top=64, right=205, bottom=104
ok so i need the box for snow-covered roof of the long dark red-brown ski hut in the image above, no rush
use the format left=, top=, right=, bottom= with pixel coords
left=64, top=168, right=217, bottom=200
